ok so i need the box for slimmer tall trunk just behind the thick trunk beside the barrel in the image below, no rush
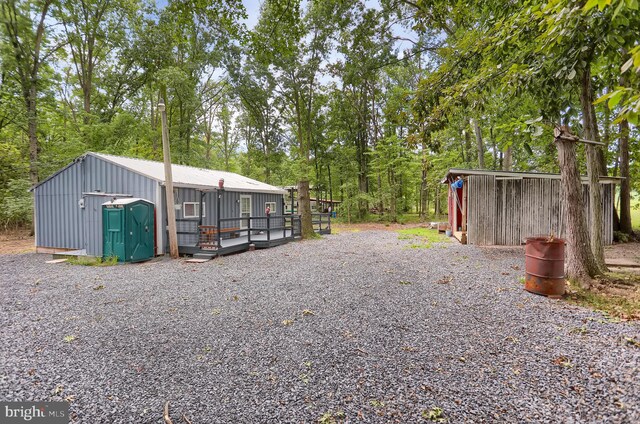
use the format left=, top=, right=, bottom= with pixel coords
left=580, top=68, right=607, bottom=271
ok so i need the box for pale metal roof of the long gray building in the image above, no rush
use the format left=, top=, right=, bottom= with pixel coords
left=32, top=152, right=286, bottom=194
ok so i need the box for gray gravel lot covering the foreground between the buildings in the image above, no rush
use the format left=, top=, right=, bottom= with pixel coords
left=0, top=231, right=640, bottom=424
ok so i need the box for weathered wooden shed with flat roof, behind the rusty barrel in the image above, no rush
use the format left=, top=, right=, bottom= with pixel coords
left=442, top=169, right=620, bottom=246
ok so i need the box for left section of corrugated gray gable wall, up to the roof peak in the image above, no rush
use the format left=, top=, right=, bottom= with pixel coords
left=34, top=162, right=85, bottom=249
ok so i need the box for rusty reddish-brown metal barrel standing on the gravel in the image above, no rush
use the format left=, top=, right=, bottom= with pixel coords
left=524, top=237, right=565, bottom=297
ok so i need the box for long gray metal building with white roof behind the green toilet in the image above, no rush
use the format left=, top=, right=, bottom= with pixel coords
left=32, top=152, right=285, bottom=256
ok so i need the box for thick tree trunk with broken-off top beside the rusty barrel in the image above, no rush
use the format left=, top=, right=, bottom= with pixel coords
left=556, top=130, right=600, bottom=289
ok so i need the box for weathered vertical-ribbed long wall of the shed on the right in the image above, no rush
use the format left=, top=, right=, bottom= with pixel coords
left=467, top=175, right=615, bottom=245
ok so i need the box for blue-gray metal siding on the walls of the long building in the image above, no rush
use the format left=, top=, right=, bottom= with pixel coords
left=34, top=155, right=282, bottom=256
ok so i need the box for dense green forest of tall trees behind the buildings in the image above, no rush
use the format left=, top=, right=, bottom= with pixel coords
left=0, top=0, right=640, bottom=234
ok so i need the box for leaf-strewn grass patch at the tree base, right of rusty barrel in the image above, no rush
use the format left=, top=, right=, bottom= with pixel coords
left=568, top=273, right=640, bottom=320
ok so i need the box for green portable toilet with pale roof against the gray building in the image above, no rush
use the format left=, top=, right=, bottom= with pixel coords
left=102, top=199, right=155, bottom=262
